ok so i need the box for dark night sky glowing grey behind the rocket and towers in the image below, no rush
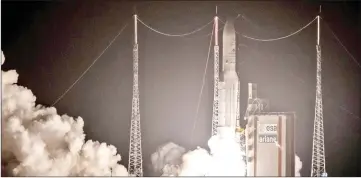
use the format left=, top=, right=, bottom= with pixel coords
left=1, top=0, right=361, bottom=176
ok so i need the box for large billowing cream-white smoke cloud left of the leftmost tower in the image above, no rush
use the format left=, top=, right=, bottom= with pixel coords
left=1, top=51, right=128, bottom=176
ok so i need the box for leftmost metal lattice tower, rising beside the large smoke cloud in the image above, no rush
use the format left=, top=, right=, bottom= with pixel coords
left=128, top=15, right=143, bottom=177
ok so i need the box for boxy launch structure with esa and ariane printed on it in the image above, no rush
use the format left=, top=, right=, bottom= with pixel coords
left=245, top=112, right=295, bottom=177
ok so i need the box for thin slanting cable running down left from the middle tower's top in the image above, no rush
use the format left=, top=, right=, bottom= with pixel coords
left=191, top=22, right=214, bottom=144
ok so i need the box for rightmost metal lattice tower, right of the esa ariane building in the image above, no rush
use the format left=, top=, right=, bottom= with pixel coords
left=311, top=16, right=326, bottom=177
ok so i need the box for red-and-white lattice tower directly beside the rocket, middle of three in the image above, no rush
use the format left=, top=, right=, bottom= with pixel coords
left=212, top=16, right=219, bottom=136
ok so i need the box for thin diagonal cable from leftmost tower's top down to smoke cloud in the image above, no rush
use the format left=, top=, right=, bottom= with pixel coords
left=51, top=24, right=128, bottom=106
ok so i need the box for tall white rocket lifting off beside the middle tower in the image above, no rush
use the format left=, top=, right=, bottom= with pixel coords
left=218, top=20, right=240, bottom=136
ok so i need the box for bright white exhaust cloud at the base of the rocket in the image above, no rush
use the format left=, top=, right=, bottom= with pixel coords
left=152, top=131, right=245, bottom=176
